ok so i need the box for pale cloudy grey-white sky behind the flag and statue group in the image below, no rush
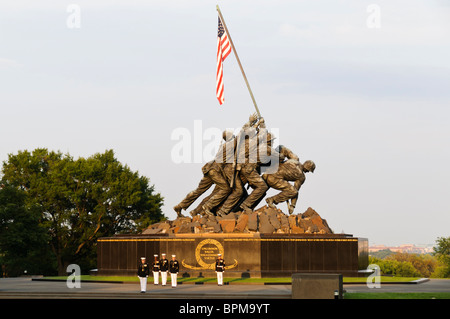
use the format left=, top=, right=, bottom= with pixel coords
left=0, top=0, right=450, bottom=245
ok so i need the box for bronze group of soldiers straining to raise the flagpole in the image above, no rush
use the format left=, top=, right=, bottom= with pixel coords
left=174, top=114, right=316, bottom=217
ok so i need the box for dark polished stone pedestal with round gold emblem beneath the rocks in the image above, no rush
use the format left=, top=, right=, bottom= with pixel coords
left=97, top=233, right=368, bottom=278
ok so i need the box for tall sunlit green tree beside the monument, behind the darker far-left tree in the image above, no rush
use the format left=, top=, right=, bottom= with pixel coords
left=2, top=149, right=164, bottom=275
